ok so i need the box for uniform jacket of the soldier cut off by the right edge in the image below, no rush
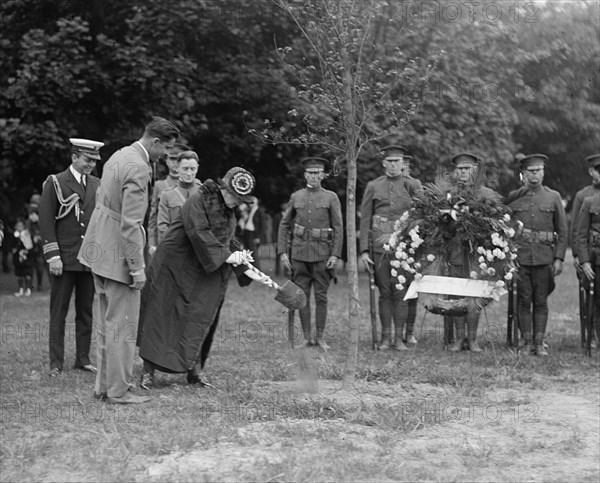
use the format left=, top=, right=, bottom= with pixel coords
left=575, top=192, right=600, bottom=265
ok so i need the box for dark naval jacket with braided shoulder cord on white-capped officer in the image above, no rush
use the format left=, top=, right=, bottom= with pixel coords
left=39, top=168, right=100, bottom=271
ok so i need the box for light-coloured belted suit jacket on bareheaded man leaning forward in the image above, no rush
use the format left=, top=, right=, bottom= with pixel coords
left=79, top=142, right=152, bottom=285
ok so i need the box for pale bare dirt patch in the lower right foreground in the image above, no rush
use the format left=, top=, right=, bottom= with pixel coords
left=138, top=381, right=600, bottom=481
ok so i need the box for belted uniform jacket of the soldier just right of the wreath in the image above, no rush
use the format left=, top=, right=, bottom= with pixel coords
left=506, top=186, right=568, bottom=266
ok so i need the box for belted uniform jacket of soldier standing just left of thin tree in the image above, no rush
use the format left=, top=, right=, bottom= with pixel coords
left=277, top=188, right=344, bottom=262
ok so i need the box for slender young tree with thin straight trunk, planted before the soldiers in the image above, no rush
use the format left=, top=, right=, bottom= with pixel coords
left=250, top=0, right=433, bottom=383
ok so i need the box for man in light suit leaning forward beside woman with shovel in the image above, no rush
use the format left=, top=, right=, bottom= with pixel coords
left=79, top=117, right=179, bottom=404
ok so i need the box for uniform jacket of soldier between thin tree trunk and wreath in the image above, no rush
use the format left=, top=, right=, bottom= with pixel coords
left=360, top=176, right=423, bottom=253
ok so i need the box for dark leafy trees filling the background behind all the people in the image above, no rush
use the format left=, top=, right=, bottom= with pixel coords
left=0, top=0, right=600, bottom=219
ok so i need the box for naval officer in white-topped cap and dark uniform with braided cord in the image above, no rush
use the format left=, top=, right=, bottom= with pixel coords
left=39, top=138, right=104, bottom=377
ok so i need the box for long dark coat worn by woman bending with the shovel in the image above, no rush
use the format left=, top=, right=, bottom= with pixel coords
left=138, top=180, right=250, bottom=372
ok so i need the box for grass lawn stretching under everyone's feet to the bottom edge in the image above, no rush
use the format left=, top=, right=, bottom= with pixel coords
left=0, top=248, right=600, bottom=482
